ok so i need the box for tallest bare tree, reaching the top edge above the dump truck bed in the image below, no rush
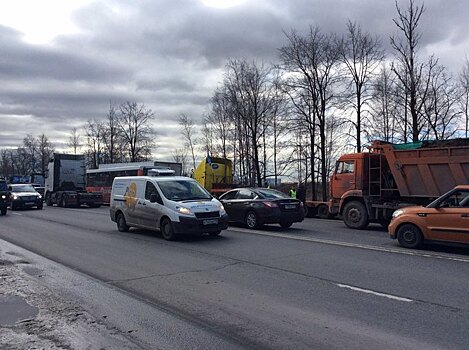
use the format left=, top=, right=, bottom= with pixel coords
left=391, top=0, right=437, bottom=142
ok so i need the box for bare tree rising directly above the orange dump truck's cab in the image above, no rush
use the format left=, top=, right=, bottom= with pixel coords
left=339, top=21, right=384, bottom=152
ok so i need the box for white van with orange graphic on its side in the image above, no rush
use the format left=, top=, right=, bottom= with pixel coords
left=110, top=176, right=228, bottom=240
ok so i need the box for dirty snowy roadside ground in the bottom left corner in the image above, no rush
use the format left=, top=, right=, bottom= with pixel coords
left=0, top=248, right=140, bottom=350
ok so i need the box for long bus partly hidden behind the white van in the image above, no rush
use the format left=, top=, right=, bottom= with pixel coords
left=86, top=162, right=182, bottom=204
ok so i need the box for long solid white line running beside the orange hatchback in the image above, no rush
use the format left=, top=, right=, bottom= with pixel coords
left=229, top=227, right=469, bottom=263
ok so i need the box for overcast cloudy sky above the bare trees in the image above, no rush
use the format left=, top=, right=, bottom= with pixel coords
left=0, top=0, right=469, bottom=159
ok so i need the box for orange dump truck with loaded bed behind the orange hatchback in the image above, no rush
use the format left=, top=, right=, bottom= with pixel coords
left=306, top=139, right=469, bottom=229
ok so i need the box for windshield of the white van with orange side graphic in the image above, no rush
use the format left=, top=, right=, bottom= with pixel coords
left=158, top=180, right=212, bottom=201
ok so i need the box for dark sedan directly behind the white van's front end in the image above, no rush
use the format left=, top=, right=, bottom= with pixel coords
left=219, top=188, right=304, bottom=229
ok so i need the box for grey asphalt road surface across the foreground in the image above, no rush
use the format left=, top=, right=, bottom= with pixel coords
left=0, top=207, right=469, bottom=349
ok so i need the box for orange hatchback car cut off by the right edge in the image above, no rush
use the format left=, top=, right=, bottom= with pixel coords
left=388, top=185, right=469, bottom=248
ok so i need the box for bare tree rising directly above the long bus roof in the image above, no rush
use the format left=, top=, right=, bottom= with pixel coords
left=119, top=102, right=155, bottom=162
